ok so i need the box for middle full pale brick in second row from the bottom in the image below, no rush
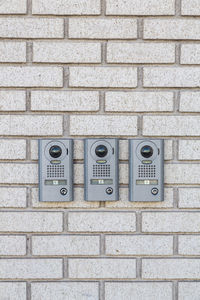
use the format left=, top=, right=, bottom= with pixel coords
left=69, top=258, right=136, bottom=279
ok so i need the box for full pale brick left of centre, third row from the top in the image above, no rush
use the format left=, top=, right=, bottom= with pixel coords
left=33, top=41, right=101, bottom=63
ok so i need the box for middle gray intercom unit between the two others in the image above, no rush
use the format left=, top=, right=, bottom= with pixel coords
left=84, top=139, right=119, bottom=201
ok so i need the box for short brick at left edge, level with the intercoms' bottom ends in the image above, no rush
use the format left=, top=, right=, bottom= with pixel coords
left=0, top=187, right=26, bottom=208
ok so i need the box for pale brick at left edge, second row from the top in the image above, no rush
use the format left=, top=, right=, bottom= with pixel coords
left=0, top=18, right=64, bottom=39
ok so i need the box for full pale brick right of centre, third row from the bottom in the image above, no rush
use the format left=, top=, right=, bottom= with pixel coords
left=105, top=235, right=173, bottom=255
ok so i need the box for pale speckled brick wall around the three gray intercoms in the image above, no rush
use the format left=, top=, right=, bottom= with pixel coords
left=0, top=0, right=200, bottom=300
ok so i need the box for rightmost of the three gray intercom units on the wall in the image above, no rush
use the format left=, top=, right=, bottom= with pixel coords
left=129, top=139, right=164, bottom=202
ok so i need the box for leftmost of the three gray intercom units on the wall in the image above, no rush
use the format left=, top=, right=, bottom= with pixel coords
left=38, top=139, right=73, bottom=202
